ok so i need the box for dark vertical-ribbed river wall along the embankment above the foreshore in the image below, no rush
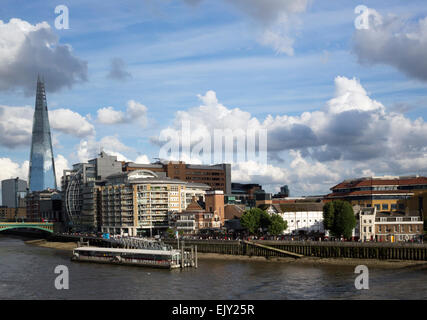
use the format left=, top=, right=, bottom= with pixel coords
left=49, top=235, right=427, bottom=261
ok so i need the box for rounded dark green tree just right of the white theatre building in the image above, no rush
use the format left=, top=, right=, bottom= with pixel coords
left=323, top=200, right=356, bottom=239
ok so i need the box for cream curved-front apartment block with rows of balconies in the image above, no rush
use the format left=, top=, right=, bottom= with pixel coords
left=99, top=170, right=210, bottom=236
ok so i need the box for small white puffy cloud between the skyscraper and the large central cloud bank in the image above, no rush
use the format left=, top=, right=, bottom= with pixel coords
left=97, top=100, right=147, bottom=127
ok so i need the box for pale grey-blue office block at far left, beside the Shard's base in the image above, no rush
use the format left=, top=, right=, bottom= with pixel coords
left=1, top=178, right=27, bottom=208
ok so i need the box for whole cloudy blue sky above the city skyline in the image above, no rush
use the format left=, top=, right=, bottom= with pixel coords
left=0, top=0, right=427, bottom=196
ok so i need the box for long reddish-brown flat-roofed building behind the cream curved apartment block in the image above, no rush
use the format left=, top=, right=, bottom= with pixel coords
left=123, top=160, right=231, bottom=194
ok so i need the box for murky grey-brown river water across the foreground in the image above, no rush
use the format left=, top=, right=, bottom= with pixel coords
left=0, top=236, right=427, bottom=300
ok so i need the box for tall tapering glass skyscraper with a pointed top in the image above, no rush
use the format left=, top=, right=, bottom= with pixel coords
left=29, top=77, right=57, bottom=192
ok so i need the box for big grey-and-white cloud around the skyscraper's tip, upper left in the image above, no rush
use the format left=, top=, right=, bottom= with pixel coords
left=0, top=18, right=87, bottom=95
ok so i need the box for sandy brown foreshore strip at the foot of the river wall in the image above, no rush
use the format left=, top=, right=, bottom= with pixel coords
left=25, top=239, right=427, bottom=269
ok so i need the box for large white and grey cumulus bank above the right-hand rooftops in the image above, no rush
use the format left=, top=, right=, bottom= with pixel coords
left=151, top=77, right=427, bottom=193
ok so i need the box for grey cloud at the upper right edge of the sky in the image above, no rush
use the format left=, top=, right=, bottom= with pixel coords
left=353, top=9, right=427, bottom=81
